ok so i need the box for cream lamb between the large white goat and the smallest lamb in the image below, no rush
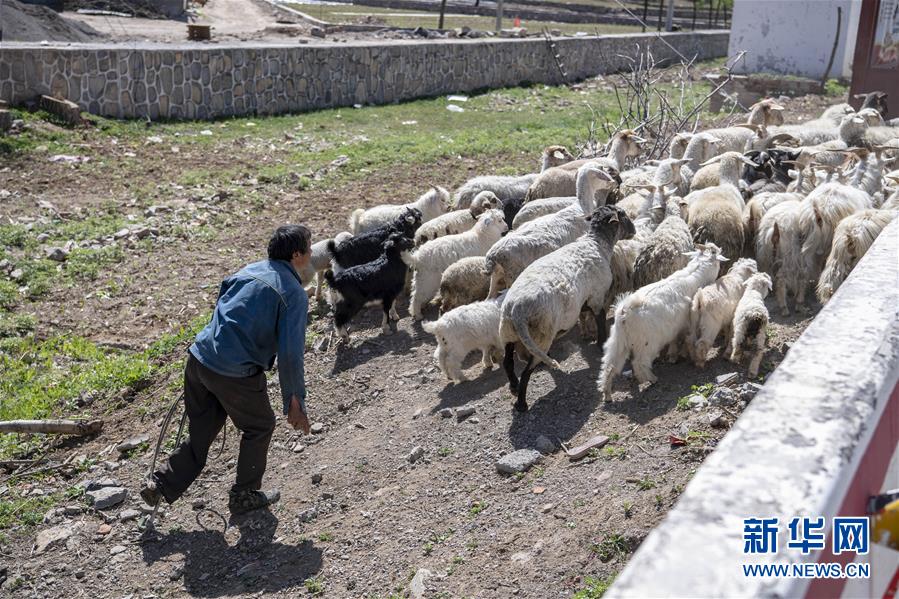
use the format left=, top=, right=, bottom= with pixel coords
left=689, top=258, right=758, bottom=368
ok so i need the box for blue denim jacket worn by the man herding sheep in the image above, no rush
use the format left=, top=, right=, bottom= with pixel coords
left=190, top=260, right=309, bottom=414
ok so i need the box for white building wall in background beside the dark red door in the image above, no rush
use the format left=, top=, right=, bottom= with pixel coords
left=728, top=0, right=862, bottom=78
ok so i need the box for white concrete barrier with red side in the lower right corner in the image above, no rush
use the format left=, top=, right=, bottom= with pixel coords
left=605, top=220, right=899, bottom=598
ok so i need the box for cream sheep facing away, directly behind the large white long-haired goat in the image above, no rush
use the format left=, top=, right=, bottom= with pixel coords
left=634, top=200, right=693, bottom=289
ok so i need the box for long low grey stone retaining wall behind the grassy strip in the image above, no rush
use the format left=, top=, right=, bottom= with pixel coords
left=0, top=32, right=728, bottom=119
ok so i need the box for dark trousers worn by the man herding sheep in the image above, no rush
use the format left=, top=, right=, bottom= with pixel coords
left=154, top=353, right=275, bottom=503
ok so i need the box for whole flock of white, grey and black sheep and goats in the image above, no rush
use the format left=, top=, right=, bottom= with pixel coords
left=300, top=92, right=899, bottom=411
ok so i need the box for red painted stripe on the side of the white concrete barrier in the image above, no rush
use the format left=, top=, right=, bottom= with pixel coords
left=805, top=385, right=899, bottom=599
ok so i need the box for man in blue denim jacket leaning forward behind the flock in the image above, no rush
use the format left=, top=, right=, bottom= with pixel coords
left=141, top=225, right=311, bottom=514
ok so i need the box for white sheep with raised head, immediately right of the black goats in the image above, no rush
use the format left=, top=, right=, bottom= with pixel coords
left=410, top=210, right=509, bottom=320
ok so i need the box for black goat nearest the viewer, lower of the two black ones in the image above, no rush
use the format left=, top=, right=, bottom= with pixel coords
left=325, top=233, right=414, bottom=341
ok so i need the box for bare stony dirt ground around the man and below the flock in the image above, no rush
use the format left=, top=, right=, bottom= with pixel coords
left=0, top=86, right=844, bottom=599
